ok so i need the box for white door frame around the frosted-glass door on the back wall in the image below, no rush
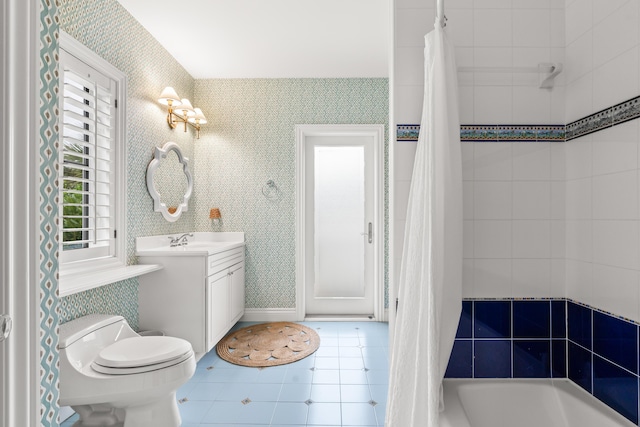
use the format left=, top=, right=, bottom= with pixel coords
left=295, top=124, right=385, bottom=321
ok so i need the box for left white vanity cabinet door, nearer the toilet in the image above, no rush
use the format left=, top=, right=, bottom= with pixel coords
left=206, top=270, right=230, bottom=351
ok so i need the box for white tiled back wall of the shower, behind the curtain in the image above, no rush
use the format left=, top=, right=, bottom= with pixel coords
left=393, top=0, right=565, bottom=298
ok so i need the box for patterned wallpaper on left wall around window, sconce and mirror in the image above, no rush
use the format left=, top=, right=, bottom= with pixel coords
left=59, top=0, right=194, bottom=328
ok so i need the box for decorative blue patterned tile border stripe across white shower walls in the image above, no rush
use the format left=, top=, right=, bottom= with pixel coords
left=396, top=96, right=640, bottom=142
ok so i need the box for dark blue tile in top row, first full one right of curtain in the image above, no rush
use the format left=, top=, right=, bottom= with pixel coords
left=473, top=301, right=511, bottom=338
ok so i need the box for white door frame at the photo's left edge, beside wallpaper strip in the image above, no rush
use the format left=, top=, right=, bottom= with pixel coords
left=0, top=0, right=40, bottom=426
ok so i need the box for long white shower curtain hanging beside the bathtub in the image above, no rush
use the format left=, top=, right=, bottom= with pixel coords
left=385, top=19, right=462, bottom=427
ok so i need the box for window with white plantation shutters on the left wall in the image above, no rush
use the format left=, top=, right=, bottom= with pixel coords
left=59, top=36, right=124, bottom=270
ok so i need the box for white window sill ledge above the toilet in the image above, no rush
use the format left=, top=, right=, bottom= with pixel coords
left=58, top=264, right=162, bottom=297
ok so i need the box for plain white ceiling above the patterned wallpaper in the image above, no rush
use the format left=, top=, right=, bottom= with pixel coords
left=118, top=0, right=391, bottom=79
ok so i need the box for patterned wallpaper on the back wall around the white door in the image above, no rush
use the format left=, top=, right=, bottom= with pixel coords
left=193, top=79, right=389, bottom=308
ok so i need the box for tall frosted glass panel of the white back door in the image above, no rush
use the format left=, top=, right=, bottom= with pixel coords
left=314, top=146, right=365, bottom=298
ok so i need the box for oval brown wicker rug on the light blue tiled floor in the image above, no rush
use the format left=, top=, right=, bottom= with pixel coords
left=216, top=322, right=320, bottom=367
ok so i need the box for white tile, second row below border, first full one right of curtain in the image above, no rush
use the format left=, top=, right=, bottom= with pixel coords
left=473, top=181, right=512, bottom=219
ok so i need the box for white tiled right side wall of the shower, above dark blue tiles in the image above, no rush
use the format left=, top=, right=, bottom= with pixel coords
left=564, top=0, right=640, bottom=321
